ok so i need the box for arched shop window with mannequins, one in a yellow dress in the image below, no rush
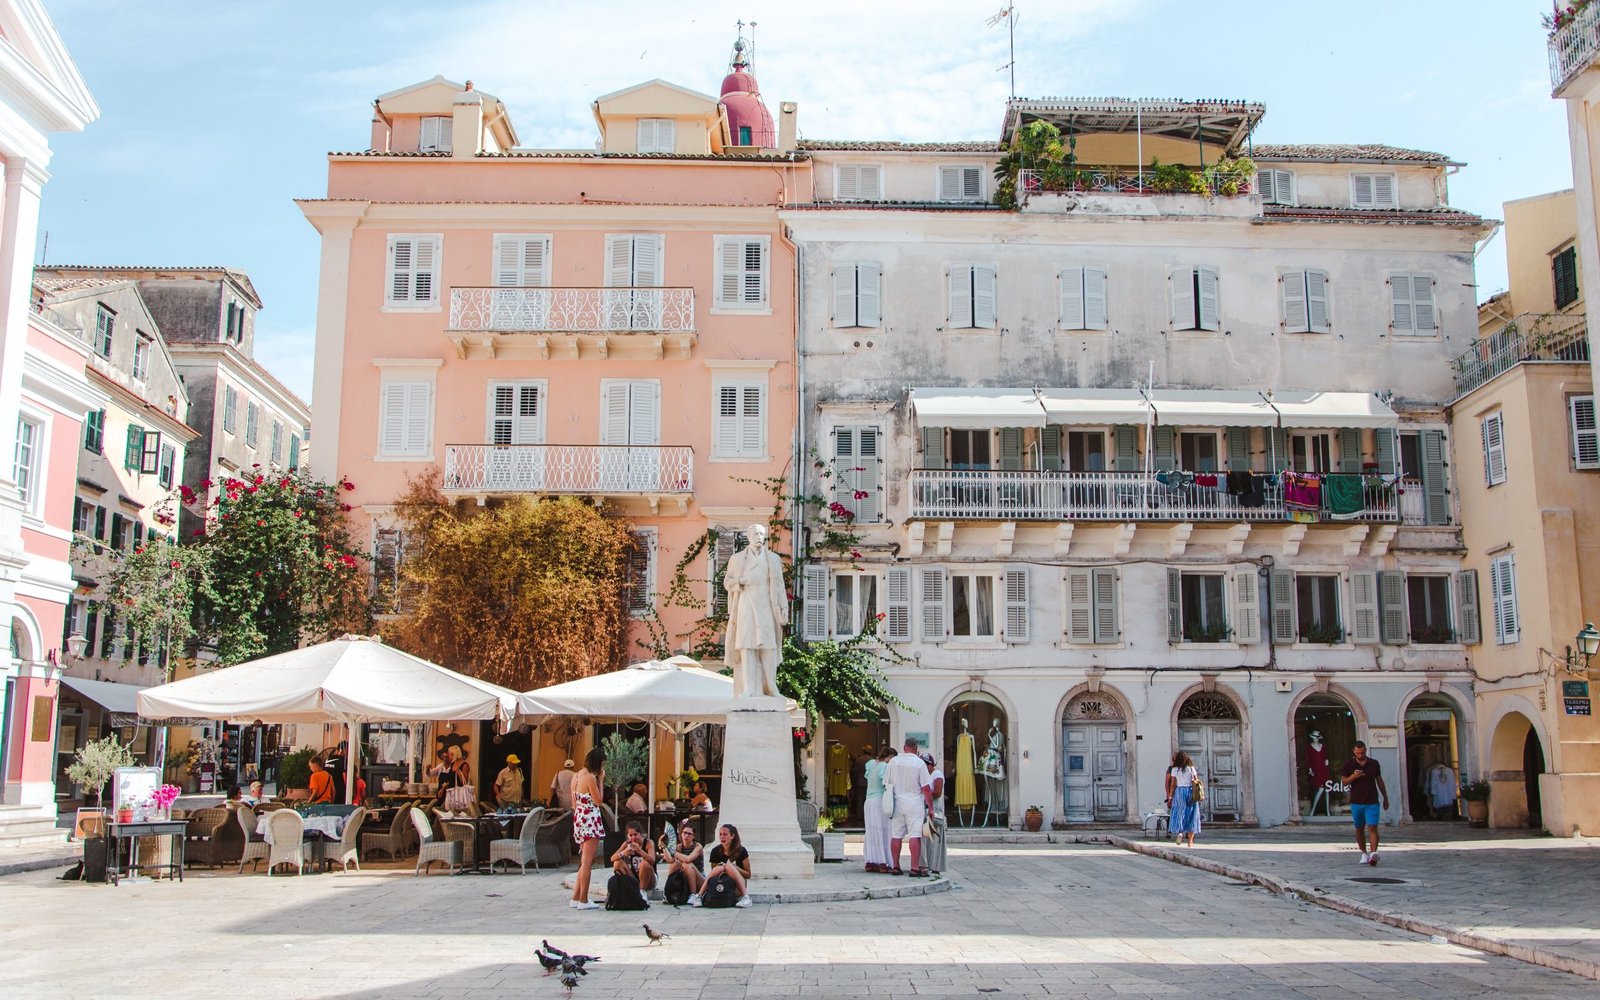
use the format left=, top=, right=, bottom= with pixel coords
left=944, top=691, right=1013, bottom=829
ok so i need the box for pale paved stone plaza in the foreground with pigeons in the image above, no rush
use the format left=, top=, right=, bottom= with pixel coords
left=0, top=843, right=1600, bottom=1000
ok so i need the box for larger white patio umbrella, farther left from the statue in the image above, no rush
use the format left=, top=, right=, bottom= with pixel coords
left=139, top=635, right=518, bottom=798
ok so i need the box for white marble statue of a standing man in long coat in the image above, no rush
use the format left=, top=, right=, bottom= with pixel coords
left=722, top=525, right=789, bottom=699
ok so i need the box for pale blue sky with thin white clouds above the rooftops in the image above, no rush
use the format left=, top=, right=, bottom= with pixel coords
left=35, top=0, right=1571, bottom=402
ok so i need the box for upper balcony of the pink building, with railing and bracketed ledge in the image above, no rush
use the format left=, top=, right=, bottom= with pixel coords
left=445, top=286, right=696, bottom=362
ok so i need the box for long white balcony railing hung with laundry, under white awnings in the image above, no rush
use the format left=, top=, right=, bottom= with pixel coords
left=910, top=469, right=1426, bottom=525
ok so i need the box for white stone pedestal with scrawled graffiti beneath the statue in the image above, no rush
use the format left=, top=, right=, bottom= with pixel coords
left=723, top=698, right=816, bottom=878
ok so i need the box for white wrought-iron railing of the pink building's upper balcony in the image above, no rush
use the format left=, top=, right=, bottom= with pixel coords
left=450, top=288, right=694, bottom=333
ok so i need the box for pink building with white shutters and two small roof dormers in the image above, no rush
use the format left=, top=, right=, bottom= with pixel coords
left=301, top=48, right=810, bottom=781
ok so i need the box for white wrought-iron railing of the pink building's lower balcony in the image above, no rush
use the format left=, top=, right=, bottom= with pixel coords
left=445, top=445, right=694, bottom=493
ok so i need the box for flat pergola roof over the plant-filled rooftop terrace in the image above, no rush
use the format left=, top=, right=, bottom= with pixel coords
left=1000, top=98, right=1267, bottom=154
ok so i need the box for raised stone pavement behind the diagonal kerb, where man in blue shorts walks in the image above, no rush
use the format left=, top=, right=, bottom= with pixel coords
left=1104, top=824, right=1600, bottom=995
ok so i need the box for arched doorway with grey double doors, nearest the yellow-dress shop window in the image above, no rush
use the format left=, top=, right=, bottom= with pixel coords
left=1061, top=691, right=1128, bottom=822
